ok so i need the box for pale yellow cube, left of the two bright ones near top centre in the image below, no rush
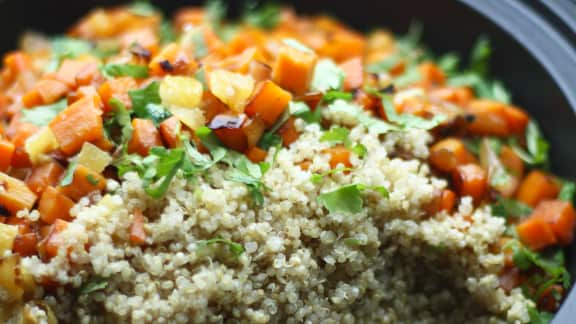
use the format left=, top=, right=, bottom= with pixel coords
left=159, top=76, right=203, bottom=108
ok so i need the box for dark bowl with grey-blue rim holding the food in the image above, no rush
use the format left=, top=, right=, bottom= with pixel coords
left=0, top=0, right=576, bottom=324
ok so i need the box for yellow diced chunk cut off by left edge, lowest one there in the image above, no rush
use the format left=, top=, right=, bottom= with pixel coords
left=0, top=254, right=24, bottom=304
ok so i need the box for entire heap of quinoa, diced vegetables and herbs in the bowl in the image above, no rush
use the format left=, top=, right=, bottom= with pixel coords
left=0, top=1, right=576, bottom=324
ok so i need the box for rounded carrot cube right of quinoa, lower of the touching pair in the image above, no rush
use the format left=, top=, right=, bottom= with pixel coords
left=452, top=163, right=488, bottom=203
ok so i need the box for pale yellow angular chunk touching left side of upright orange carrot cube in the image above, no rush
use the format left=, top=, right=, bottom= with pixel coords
left=208, top=70, right=255, bottom=113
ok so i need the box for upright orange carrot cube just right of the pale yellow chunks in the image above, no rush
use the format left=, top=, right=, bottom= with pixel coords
left=272, top=45, right=318, bottom=95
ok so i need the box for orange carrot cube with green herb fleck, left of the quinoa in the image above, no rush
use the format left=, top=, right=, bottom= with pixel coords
left=59, top=165, right=106, bottom=201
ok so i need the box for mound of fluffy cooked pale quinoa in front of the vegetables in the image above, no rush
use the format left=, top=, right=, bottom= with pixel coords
left=22, top=113, right=533, bottom=323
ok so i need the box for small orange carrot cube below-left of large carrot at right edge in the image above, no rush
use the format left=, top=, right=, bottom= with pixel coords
left=516, top=217, right=558, bottom=251
